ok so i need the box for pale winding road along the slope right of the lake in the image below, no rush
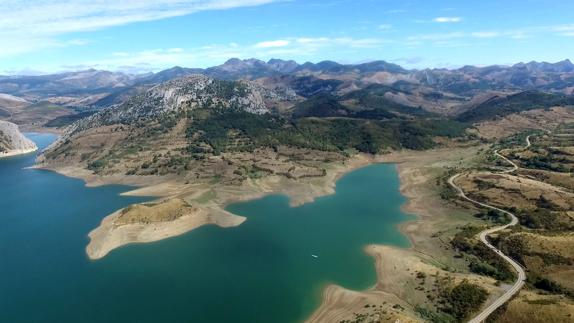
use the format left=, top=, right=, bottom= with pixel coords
left=448, top=136, right=530, bottom=323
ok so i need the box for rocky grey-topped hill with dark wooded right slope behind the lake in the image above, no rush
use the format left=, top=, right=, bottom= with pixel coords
left=42, top=75, right=467, bottom=183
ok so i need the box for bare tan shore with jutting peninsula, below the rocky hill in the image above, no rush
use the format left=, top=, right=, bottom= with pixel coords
left=39, top=154, right=382, bottom=260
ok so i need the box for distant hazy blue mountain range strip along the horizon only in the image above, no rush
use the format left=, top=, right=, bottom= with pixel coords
left=0, top=58, right=574, bottom=107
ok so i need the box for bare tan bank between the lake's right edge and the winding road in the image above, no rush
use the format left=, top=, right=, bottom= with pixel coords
left=306, top=148, right=510, bottom=323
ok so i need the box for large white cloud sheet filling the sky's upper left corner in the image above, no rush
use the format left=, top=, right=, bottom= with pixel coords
left=0, top=0, right=279, bottom=57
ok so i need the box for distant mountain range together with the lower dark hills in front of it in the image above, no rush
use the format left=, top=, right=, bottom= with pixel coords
left=0, top=58, right=574, bottom=137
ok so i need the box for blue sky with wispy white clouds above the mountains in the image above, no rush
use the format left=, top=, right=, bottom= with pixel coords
left=0, top=0, right=574, bottom=74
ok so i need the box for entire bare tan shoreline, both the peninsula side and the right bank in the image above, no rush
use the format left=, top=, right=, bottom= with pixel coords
left=36, top=147, right=504, bottom=322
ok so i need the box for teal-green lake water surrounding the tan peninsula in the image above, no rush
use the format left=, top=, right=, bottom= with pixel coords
left=0, top=134, right=411, bottom=322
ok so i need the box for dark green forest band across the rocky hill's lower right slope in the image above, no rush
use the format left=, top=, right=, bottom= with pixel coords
left=187, top=109, right=466, bottom=154
